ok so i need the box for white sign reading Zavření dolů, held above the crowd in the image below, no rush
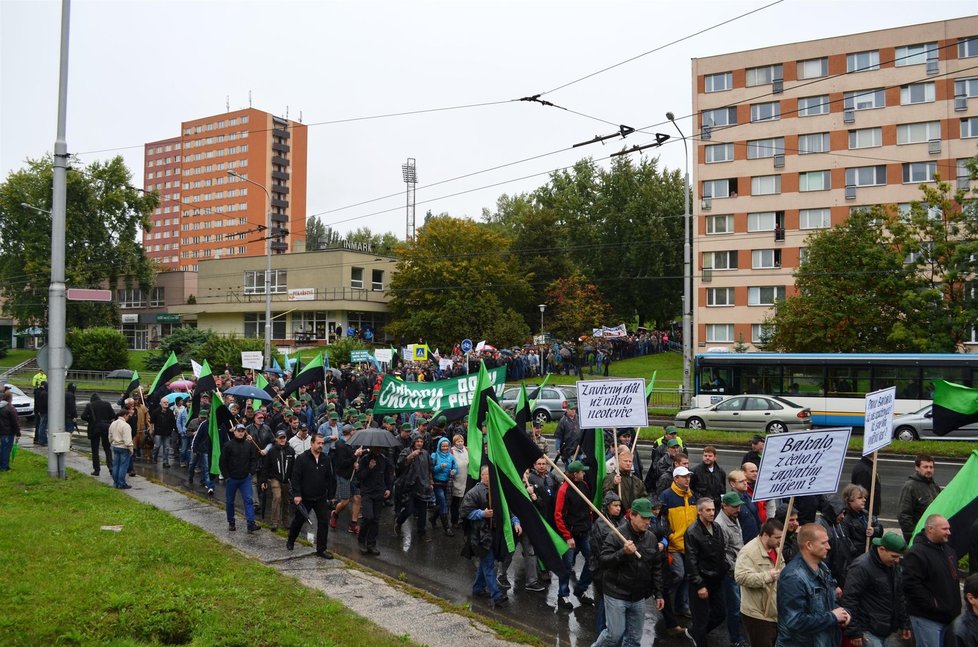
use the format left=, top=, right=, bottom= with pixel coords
left=577, top=378, right=649, bottom=429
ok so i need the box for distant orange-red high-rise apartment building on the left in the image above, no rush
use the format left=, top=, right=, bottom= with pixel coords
left=143, top=108, right=308, bottom=271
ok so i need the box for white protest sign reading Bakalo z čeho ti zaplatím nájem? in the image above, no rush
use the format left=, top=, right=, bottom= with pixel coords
left=754, top=427, right=852, bottom=501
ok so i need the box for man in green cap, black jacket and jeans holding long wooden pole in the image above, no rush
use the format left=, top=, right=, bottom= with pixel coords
left=593, top=498, right=665, bottom=647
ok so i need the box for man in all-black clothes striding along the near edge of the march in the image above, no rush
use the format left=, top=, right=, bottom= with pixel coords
left=285, top=433, right=336, bottom=559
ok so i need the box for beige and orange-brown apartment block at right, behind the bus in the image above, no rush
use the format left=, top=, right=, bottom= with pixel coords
left=693, top=17, right=978, bottom=352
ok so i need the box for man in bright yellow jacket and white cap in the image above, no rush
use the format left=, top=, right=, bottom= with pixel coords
left=659, top=467, right=696, bottom=634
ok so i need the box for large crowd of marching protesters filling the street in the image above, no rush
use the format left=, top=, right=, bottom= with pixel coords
left=9, top=349, right=978, bottom=647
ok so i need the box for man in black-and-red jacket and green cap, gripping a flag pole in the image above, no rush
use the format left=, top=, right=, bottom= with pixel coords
left=554, top=461, right=594, bottom=609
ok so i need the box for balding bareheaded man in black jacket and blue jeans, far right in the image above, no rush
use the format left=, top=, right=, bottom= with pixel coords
left=903, top=514, right=961, bottom=647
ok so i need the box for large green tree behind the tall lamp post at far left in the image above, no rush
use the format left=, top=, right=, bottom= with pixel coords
left=0, top=157, right=159, bottom=328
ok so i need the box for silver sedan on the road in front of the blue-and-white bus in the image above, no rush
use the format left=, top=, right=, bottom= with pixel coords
left=676, top=394, right=812, bottom=434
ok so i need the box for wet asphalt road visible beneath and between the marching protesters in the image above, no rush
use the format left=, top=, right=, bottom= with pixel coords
left=28, top=420, right=959, bottom=647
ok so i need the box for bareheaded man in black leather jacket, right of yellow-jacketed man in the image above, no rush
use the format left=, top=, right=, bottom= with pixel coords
left=683, top=497, right=729, bottom=647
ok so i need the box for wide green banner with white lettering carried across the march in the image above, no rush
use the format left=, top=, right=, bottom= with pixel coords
left=366, top=366, right=506, bottom=415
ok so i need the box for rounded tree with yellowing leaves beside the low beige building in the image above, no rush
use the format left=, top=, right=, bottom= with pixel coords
left=387, top=216, right=532, bottom=348
